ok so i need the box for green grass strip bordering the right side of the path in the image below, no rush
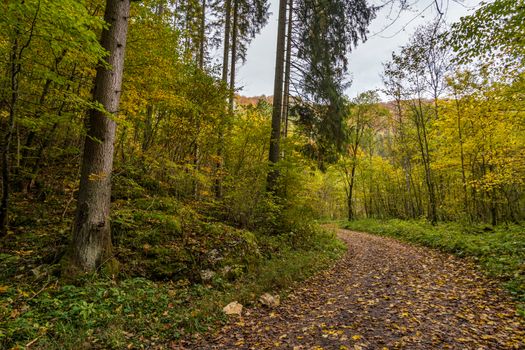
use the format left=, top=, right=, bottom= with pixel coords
left=342, top=219, right=525, bottom=317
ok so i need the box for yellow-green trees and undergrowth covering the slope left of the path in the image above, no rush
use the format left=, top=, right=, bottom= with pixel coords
left=0, top=0, right=343, bottom=349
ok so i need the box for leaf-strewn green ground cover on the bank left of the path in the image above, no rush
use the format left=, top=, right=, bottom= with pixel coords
left=0, top=197, right=344, bottom=349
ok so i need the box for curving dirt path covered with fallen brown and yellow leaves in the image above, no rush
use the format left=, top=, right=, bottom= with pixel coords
left=177, top=230, right=525, bottom=350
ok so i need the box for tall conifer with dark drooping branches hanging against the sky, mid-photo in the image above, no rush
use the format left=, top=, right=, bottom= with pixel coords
left=293, top=0, right=376, bottom=169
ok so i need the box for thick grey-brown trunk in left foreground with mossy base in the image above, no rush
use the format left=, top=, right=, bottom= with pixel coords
left=70, top=0, right=130, bottom=272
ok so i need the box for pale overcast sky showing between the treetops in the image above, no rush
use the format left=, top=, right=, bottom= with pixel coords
left=236, top=0, right=481, bottom=98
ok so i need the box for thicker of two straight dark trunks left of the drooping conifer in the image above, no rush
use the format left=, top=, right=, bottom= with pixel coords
left=266, top=0, right=286, bottom=192
